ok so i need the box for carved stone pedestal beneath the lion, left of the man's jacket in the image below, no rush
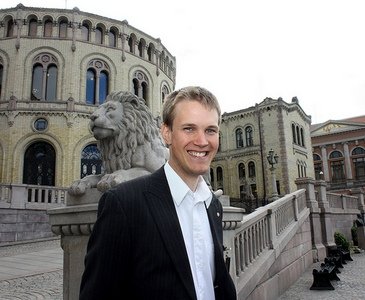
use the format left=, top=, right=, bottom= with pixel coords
left=48, top=189, right=101, bottom=300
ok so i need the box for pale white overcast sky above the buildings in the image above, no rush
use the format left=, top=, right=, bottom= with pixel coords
left=0, top=0, right=365, bottom=124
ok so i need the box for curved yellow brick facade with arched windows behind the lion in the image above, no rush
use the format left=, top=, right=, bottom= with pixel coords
left=0, top=4, right=176, bottom=187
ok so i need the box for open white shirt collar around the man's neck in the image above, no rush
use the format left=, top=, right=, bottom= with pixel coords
left=164, top=162, right=212, bottom=208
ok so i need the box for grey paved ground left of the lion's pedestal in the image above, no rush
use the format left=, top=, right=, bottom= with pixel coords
left=0, top=240, right=63, bottom=300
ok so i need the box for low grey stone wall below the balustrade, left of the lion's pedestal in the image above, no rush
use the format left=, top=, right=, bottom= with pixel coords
left=0, top=209, right=55, bottom=243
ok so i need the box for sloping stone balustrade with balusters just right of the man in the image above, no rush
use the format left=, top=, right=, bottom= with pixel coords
left=223, top=190, right=309, bottom=299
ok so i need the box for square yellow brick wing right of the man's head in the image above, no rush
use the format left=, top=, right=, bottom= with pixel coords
left=210, top=97, right=314, bottom=206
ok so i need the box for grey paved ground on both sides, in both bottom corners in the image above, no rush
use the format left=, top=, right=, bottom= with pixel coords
left=0, top=240, right=365, bottom=300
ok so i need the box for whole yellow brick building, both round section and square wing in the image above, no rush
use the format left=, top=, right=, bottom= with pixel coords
left=0, top=4, right=315, bottom=206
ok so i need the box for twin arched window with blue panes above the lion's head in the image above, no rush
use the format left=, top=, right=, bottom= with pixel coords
left=86, top=60, right=109, bottom=105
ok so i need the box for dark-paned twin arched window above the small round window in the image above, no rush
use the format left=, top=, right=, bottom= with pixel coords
left=31, top=53, right=58, bottom=101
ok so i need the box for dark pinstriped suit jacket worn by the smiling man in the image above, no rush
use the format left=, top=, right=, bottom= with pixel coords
left=80, top=168, right=236, bottom=300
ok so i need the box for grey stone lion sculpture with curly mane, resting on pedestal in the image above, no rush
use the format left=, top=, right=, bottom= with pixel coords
left=69, top=91, right=168, bottom=195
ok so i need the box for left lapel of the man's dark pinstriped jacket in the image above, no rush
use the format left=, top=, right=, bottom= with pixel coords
left=146, top=168, right=196, bottom=299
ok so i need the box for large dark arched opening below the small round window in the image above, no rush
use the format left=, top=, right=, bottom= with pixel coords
left=23, top=142, right=56, bottom=186
